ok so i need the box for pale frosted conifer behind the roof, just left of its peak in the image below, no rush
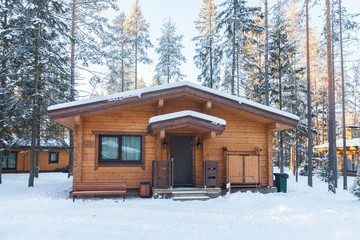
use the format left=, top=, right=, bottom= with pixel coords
left=155, top=17, right=186, bottom=83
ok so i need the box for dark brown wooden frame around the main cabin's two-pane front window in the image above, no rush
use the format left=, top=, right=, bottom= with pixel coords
left=92, top=131, right=146, bottom=170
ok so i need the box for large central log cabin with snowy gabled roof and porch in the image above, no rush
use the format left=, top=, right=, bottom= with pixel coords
left=48, top=81, right=298, bottom=194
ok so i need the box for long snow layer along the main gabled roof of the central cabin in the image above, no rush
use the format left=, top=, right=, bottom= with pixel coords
left=48, top=81, right=299, bottom=121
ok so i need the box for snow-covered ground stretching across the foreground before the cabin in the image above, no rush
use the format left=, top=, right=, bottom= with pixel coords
left=0, top=173, right=360, bottom=240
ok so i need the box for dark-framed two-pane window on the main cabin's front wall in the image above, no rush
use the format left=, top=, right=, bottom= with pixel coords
left=93, top=132, right=145, bottom=169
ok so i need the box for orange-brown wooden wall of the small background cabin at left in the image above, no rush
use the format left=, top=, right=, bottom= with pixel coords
left=4, top=149, right=69, bottom=172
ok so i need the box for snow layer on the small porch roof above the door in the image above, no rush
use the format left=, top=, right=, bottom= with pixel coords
left=149, top=110, right=226, bottom=126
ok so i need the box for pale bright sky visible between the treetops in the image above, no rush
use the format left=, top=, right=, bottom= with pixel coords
left=80, top=0, right=360, bottom=96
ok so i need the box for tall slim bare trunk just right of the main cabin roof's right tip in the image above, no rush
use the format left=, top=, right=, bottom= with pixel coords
left=306, top=0, right=313, bottom=187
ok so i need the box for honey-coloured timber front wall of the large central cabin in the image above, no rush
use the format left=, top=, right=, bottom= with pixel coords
left=74, top=98, right=272, bottom=188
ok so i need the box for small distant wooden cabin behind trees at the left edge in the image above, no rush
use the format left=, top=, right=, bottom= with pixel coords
left=2, top=139, right=69, bottom=173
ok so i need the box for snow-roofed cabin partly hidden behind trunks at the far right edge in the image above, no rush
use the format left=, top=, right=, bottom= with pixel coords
left=314, top=138, right=360, bottom=176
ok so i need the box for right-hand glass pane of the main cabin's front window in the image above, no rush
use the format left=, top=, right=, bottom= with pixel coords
left=121, top=136, right=141, bottom=161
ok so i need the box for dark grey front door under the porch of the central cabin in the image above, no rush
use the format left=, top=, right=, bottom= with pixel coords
left=170, top=136, right=193, bottom=186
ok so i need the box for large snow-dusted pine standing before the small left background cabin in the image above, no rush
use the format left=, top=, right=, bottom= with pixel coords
left=13, top=0, right=70, bottom=187
